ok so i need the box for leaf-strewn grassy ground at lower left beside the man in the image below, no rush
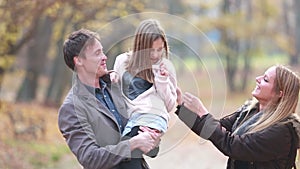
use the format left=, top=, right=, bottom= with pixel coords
left=0, top=102, right=70, bottom=169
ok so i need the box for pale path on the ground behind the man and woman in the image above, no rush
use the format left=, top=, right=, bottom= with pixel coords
left=55, top=115, right=227, bottom=169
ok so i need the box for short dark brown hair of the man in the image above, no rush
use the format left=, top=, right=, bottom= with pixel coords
left=63, top=29, right=100, bottom=70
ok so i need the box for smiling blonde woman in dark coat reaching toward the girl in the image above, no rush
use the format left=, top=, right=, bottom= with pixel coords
left=177, top=65, right=300, bottom=169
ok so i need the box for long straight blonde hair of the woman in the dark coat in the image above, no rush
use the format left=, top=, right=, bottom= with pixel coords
left=248, top=65, right=299, bottom=133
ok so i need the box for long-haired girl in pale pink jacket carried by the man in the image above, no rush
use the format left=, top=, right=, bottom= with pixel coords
left=111, top=19, right=177, bottom=169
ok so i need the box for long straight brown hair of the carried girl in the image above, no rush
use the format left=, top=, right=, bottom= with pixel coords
left=126, top=19, right=169, bottom=83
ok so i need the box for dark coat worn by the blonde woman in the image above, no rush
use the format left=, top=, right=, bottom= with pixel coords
left=177, top=100, right=300, bottom=169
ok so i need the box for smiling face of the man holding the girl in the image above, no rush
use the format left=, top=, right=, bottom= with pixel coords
left=81, top=39, right=107, bottom=78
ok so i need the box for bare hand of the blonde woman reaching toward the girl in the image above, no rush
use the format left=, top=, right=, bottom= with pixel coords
left=182, top=92, right=208, bottom=117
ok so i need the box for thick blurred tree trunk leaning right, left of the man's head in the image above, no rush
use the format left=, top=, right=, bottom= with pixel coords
left=16, top=17, right=53, bottom=102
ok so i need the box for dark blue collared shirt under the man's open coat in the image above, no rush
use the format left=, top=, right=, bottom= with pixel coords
left=85, top=78, right=124, bottom=131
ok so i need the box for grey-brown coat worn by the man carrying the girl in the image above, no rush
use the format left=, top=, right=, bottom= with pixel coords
left=58, top=76, right=131, bottom=169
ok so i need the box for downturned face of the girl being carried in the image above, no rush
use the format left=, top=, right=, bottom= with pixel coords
left=150, top=38, right=165, bottom=64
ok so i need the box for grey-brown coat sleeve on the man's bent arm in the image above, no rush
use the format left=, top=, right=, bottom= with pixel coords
left=58, top=101, right=131, bottom=169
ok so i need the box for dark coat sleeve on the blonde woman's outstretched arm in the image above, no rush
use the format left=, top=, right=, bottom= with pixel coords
left=179, top=106, right=291, bottom=161
